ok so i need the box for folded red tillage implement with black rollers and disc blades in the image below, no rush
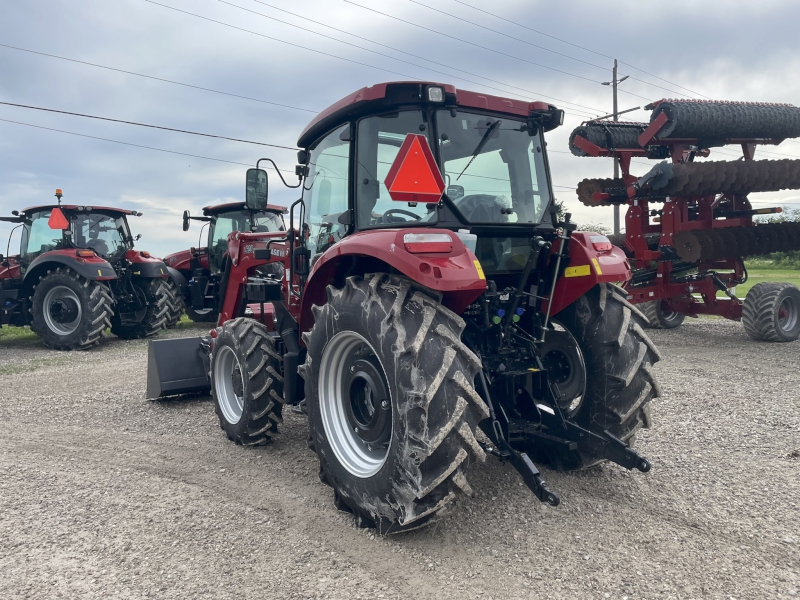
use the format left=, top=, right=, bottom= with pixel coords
left=570, top=100, right=800, bottom=342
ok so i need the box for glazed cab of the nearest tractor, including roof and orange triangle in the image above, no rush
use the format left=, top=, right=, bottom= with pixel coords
left=288, top=83, right=563, bottom=273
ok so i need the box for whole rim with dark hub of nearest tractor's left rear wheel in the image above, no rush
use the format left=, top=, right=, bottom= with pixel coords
left=319, top=331, right=392, bottom=479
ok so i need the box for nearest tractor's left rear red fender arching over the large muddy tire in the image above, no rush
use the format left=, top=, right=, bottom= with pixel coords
left=300, top=228, right=486, bottom=331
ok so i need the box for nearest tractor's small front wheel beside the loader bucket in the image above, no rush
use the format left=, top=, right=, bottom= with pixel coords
left=211, top=317, right=283, bottom=446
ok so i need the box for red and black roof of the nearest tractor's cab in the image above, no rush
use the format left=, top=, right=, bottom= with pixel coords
left=297, top=81, right=555, bottom=148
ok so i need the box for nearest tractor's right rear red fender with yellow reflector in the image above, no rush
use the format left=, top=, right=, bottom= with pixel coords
left=542, top=231, right=631, bottom=315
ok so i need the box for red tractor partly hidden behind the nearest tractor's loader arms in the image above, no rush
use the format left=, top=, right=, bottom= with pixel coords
left=164, top=202, right=286, bottom=323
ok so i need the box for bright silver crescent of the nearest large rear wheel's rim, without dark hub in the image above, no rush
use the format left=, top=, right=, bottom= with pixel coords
left=319, top=331, right=391, bottom=479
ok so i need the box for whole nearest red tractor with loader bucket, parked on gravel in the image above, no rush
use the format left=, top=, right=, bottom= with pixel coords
left=147, top=82, right=659, bottom=533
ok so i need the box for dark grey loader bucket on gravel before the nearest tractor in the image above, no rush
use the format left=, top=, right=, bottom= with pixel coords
left=147, top=337, right=211, bottom=400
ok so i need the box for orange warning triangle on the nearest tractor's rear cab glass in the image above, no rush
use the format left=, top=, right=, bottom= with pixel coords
left=384, top=133, right=445, bottom=202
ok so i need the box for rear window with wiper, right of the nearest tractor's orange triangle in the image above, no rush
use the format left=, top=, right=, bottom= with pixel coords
left=436, top=110, right=550, bottom=224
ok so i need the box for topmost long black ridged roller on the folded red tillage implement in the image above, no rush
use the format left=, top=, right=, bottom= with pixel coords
left=650, top=100, right=800, bottom=146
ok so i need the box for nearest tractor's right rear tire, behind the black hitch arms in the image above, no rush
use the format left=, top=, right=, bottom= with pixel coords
left=536, top=283, right=661, bottom=470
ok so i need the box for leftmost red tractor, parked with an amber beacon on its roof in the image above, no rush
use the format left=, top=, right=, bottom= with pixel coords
left=0, top=190, right=183, bottom=350
